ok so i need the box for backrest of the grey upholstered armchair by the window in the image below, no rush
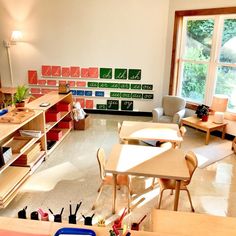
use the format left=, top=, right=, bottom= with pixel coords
left=162, top=95, right=186, bottom=116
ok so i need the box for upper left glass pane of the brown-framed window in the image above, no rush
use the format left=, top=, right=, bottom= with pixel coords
left=184, top=19, right=214, bottom=61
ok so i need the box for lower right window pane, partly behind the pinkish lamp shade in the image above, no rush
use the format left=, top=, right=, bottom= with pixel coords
left=215, top=66, right=236, bottom=112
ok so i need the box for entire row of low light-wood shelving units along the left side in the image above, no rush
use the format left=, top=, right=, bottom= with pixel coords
left=0, top=92, right=72, bottom=208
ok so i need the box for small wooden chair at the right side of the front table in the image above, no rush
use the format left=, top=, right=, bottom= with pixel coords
left=157, top=152, right=198, bottom=212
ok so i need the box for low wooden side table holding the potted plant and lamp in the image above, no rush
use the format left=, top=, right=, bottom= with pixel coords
left=181, top=115, right=227, bottom=145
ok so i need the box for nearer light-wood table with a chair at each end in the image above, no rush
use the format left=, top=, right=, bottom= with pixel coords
left=105, top=144, right=190, bottom=213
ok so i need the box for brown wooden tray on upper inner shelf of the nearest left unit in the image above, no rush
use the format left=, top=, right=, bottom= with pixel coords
left=3, top=136, right=34, bottom=153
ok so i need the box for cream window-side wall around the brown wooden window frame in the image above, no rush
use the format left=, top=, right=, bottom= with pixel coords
left=163, top=0, right=236, bottom=136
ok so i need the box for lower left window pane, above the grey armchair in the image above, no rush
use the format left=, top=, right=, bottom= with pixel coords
left=181, top=63, right=208, bottom=103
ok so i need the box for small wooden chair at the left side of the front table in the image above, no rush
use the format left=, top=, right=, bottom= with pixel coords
left=92, top=148, right=132, bottom=210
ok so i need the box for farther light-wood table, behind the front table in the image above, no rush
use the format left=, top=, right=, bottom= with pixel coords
left=119, top=121, right=183, bottom=146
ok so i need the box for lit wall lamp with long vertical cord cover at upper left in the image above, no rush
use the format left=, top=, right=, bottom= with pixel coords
left=3, top=30, right=23, bottom=87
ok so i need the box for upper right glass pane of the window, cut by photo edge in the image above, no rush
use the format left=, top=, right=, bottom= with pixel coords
left=220, top=19, right=236, bottom=63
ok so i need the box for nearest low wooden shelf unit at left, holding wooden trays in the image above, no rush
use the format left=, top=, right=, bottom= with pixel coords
left=0, top=110, right=46, bottom=208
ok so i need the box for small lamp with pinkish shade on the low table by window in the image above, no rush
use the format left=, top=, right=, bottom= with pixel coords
left=211, top=94, right=229, bottom=124
